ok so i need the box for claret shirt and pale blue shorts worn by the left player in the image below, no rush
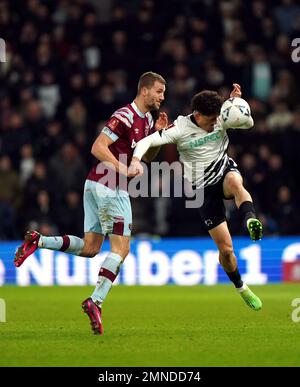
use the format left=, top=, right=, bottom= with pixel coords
left=83, top=102, right=154, bottom=236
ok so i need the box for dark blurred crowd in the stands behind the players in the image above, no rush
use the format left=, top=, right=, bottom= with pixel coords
left=0, top=0, right=300, bottom=240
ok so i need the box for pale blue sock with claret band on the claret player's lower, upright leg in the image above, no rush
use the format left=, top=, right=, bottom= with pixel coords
left=91, top=253, right=123, bottom=307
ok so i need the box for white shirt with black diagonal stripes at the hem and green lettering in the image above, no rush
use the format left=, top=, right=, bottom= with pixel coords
left=133, top=111, right=253, bottom=188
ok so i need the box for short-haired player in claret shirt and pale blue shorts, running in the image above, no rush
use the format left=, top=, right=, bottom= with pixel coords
left=14, top=72, right=168, bottom=334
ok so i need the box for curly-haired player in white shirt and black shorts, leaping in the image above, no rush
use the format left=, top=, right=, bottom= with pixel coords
left=130, top=84, right=262, bottom=310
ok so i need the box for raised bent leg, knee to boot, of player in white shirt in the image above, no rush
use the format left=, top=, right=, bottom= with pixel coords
left=223, top=172, right=263, bottom=241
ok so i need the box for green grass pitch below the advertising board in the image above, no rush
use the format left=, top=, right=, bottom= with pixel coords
left=0, top=284, right=300, bottom=367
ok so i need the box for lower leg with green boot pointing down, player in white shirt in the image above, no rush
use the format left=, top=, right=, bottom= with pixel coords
left=209, top=222, right=262, bottom=310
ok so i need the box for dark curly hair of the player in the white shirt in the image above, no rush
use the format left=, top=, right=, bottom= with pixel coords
left=192, top=90, right=224, bottom=116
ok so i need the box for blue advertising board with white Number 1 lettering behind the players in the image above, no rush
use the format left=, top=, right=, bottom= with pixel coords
left=0, top=237, right=300, bottom=286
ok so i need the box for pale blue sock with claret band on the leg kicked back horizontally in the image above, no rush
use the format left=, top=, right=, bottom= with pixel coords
left=39, top=235, right=84, bottom=255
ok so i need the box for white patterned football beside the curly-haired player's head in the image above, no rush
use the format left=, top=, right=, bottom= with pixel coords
left=220, top=97, right=251, bottom=128
